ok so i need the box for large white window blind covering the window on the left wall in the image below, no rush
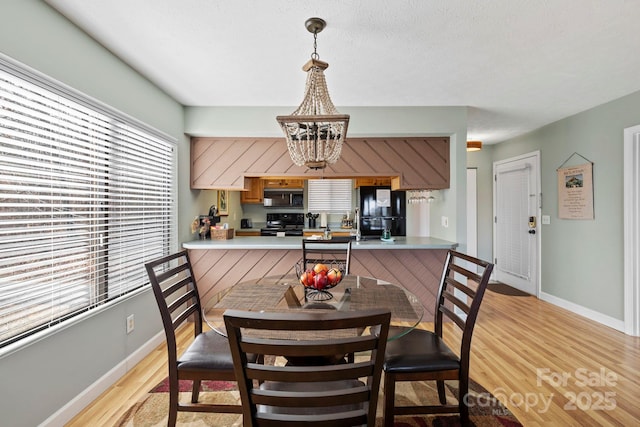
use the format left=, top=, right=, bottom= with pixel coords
left=0, top=58, right=176, bottom=346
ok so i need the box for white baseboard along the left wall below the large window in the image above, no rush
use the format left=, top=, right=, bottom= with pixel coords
left=40, top=331, right=165, bottom=427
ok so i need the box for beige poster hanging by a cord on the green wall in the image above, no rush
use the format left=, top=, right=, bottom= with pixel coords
left=558, top=163, right=594, bottom=219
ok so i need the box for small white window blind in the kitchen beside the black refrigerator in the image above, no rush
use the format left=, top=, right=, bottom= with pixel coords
left=307, top=179, right=353, bottom=213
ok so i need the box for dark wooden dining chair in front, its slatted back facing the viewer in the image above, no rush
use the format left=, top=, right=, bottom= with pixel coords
left=224, top=309, right=391, bottom=427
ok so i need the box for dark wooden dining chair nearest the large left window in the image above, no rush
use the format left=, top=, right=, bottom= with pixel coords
left=145, top=251, right=256, bottom=426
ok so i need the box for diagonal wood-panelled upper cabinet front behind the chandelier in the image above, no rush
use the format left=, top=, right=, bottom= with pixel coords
left=191, top=137, right=450, bottom=190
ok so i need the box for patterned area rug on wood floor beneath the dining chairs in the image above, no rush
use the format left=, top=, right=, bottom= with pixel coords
left=116, top=380, right=522, bottom=427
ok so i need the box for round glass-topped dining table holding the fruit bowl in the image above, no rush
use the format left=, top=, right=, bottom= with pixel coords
left=203, top=274, right=424, bottom=340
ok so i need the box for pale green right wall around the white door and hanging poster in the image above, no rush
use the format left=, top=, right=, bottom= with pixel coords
left=481, top=92, right=640, bottom=328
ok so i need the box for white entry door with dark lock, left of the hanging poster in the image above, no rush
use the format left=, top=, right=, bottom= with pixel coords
left=493, top=152, right=540, bottom=296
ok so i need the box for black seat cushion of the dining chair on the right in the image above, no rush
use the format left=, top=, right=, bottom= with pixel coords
left=384, top=329, right=460, bottom=373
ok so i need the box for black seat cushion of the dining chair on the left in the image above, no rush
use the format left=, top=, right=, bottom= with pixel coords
left=178, top=331, right=240, bottom=371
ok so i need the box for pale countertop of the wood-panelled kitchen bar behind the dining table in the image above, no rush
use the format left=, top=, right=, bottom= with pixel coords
left=182, top=236, right=458, bottom=250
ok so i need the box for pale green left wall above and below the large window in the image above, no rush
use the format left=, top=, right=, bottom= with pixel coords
left=0, top=0, right=186, bottom=427
